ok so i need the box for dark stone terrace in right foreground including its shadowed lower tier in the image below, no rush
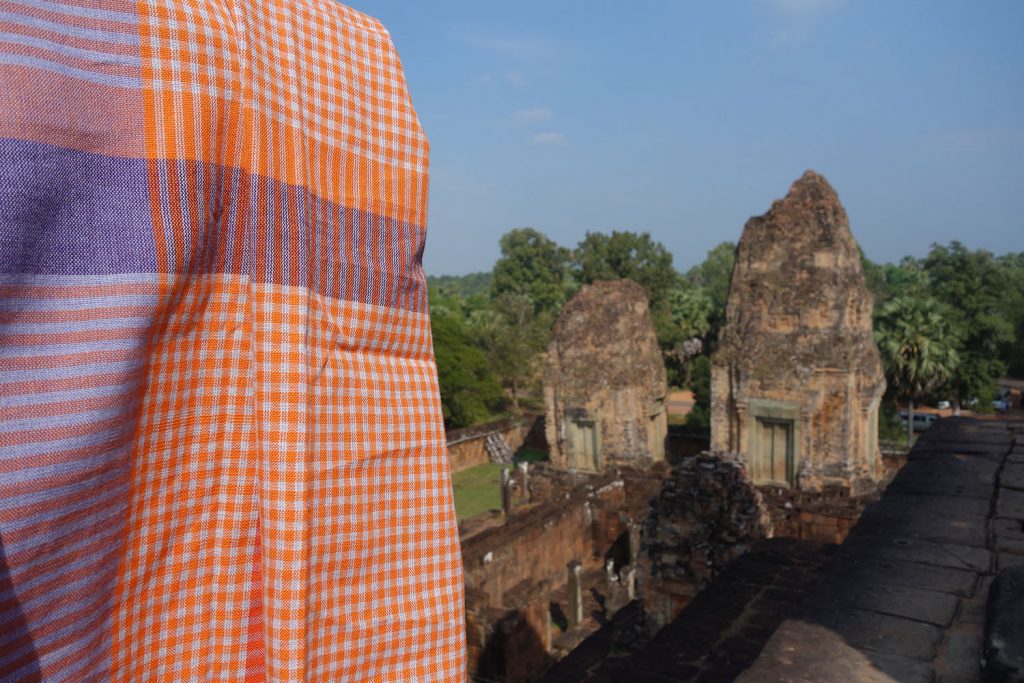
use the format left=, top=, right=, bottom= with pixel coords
left=543, top=419, right=1024, bottom=683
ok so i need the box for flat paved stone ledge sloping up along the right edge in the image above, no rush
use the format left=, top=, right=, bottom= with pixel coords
left=737, top=419, right=1024, bottom=683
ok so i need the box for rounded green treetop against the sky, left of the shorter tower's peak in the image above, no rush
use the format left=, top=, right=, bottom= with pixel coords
left=490, top=227, right=570, bottom=313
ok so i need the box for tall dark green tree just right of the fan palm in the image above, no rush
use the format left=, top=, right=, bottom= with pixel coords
left=922, top=242, right=1015, bottom=411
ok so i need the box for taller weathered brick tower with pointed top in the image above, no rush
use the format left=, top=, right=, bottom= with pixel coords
left=712, top=171, right=886, bottom=496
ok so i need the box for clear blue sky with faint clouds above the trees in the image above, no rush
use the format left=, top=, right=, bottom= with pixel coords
left=349, top=0, right=1024, bottom=274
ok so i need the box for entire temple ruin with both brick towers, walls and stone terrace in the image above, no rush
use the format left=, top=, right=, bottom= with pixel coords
left=453, top=172, right=1024, bottom=683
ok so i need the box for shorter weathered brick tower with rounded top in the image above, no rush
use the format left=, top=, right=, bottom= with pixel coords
left=544, top=280, right=668, bottom=472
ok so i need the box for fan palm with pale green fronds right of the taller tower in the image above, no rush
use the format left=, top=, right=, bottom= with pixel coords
left=874, top=297, right=959, bottom=445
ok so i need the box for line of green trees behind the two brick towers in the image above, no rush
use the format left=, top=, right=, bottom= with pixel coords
left=428, top=227, right=1024, bottom=427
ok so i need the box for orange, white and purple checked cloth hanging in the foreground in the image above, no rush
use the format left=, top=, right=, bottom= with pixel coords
left=0, top=0, right=465, bottom=681
